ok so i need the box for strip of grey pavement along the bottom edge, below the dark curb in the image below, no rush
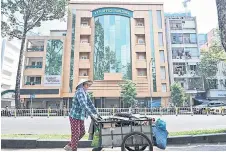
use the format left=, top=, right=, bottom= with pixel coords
left=2, top=143, right=226, bottom=151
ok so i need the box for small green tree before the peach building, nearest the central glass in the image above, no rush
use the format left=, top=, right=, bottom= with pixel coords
left=119, top=80, right=137, bottom=106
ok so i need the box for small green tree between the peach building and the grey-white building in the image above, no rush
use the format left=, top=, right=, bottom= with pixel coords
left=171, top=82, right=186, bottom=107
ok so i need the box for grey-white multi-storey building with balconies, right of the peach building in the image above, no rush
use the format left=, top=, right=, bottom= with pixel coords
left=165, top=15, right=204, bottom=104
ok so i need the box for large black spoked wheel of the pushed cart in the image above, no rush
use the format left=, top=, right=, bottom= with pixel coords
left=121, top=132, right=153, bottom=151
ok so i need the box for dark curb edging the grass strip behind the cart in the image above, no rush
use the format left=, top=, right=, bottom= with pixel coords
left=1, top=133, right=226, bottom=149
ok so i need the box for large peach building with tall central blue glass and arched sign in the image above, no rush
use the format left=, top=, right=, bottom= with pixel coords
left=21, top=1, right=170, bottom=108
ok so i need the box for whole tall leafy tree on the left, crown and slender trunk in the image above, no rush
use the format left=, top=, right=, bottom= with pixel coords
left=1, top=0, right=67, bottom=108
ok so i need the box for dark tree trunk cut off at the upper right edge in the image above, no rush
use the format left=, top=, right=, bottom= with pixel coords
left=216, top=0, right=226, bottom=51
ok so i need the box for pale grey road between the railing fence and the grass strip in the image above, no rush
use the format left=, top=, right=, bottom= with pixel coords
left=1, top=115, right=226, bottom=134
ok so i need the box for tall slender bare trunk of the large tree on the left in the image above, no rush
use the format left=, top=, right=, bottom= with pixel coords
left=15, top=34, right=26, bottom=109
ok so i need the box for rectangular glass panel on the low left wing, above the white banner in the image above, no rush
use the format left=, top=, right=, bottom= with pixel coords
left=45, top=40, right=63, bottom=75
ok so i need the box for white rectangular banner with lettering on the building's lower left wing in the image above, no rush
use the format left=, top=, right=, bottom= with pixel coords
left=44, top=75, right=61, bottom=86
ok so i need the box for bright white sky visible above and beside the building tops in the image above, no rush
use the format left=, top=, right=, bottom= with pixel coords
left=34, top=0, right=218, bottom=35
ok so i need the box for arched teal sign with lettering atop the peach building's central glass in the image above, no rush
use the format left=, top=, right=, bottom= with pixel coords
left=92, top=8, right=133, bottom=17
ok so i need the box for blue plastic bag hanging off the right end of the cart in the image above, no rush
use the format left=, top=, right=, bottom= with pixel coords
left=152, top=119, right=168, bottom=149
